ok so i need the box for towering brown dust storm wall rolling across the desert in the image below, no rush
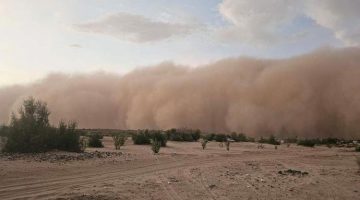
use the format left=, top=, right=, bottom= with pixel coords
left=0, top=48, right=360, bottom=137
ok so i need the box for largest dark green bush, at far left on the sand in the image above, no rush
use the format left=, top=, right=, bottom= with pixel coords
left=4, top=97, right=81, bottom=153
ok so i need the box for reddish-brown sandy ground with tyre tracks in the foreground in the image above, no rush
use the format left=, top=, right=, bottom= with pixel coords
left=0, top=138, right=360, bottom=200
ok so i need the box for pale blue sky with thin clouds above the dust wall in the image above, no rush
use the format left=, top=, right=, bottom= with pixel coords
left=0, top=0, right=360, bottom=87
